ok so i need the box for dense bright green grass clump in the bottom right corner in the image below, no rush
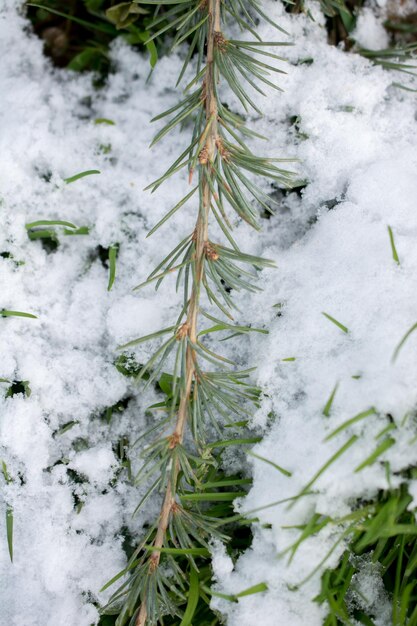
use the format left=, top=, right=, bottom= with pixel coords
left=315, top=485, right=417, bottom=626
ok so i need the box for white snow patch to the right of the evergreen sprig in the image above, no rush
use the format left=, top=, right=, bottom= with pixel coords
left=210, top=5, right=417, bottom=626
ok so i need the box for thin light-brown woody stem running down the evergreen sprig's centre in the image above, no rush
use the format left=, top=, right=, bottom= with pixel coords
left=136, top=0, right=221, bottom=626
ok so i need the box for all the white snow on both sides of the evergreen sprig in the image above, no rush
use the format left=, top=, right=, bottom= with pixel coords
left=0, top=0, right=417, bottom=626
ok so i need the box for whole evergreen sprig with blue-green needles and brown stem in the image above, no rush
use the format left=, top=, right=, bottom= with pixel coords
left=101, top=0, right=292, bottom=626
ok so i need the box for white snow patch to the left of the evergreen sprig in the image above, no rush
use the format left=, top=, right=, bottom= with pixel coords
left=0, top=2, right=186, bottom=626
